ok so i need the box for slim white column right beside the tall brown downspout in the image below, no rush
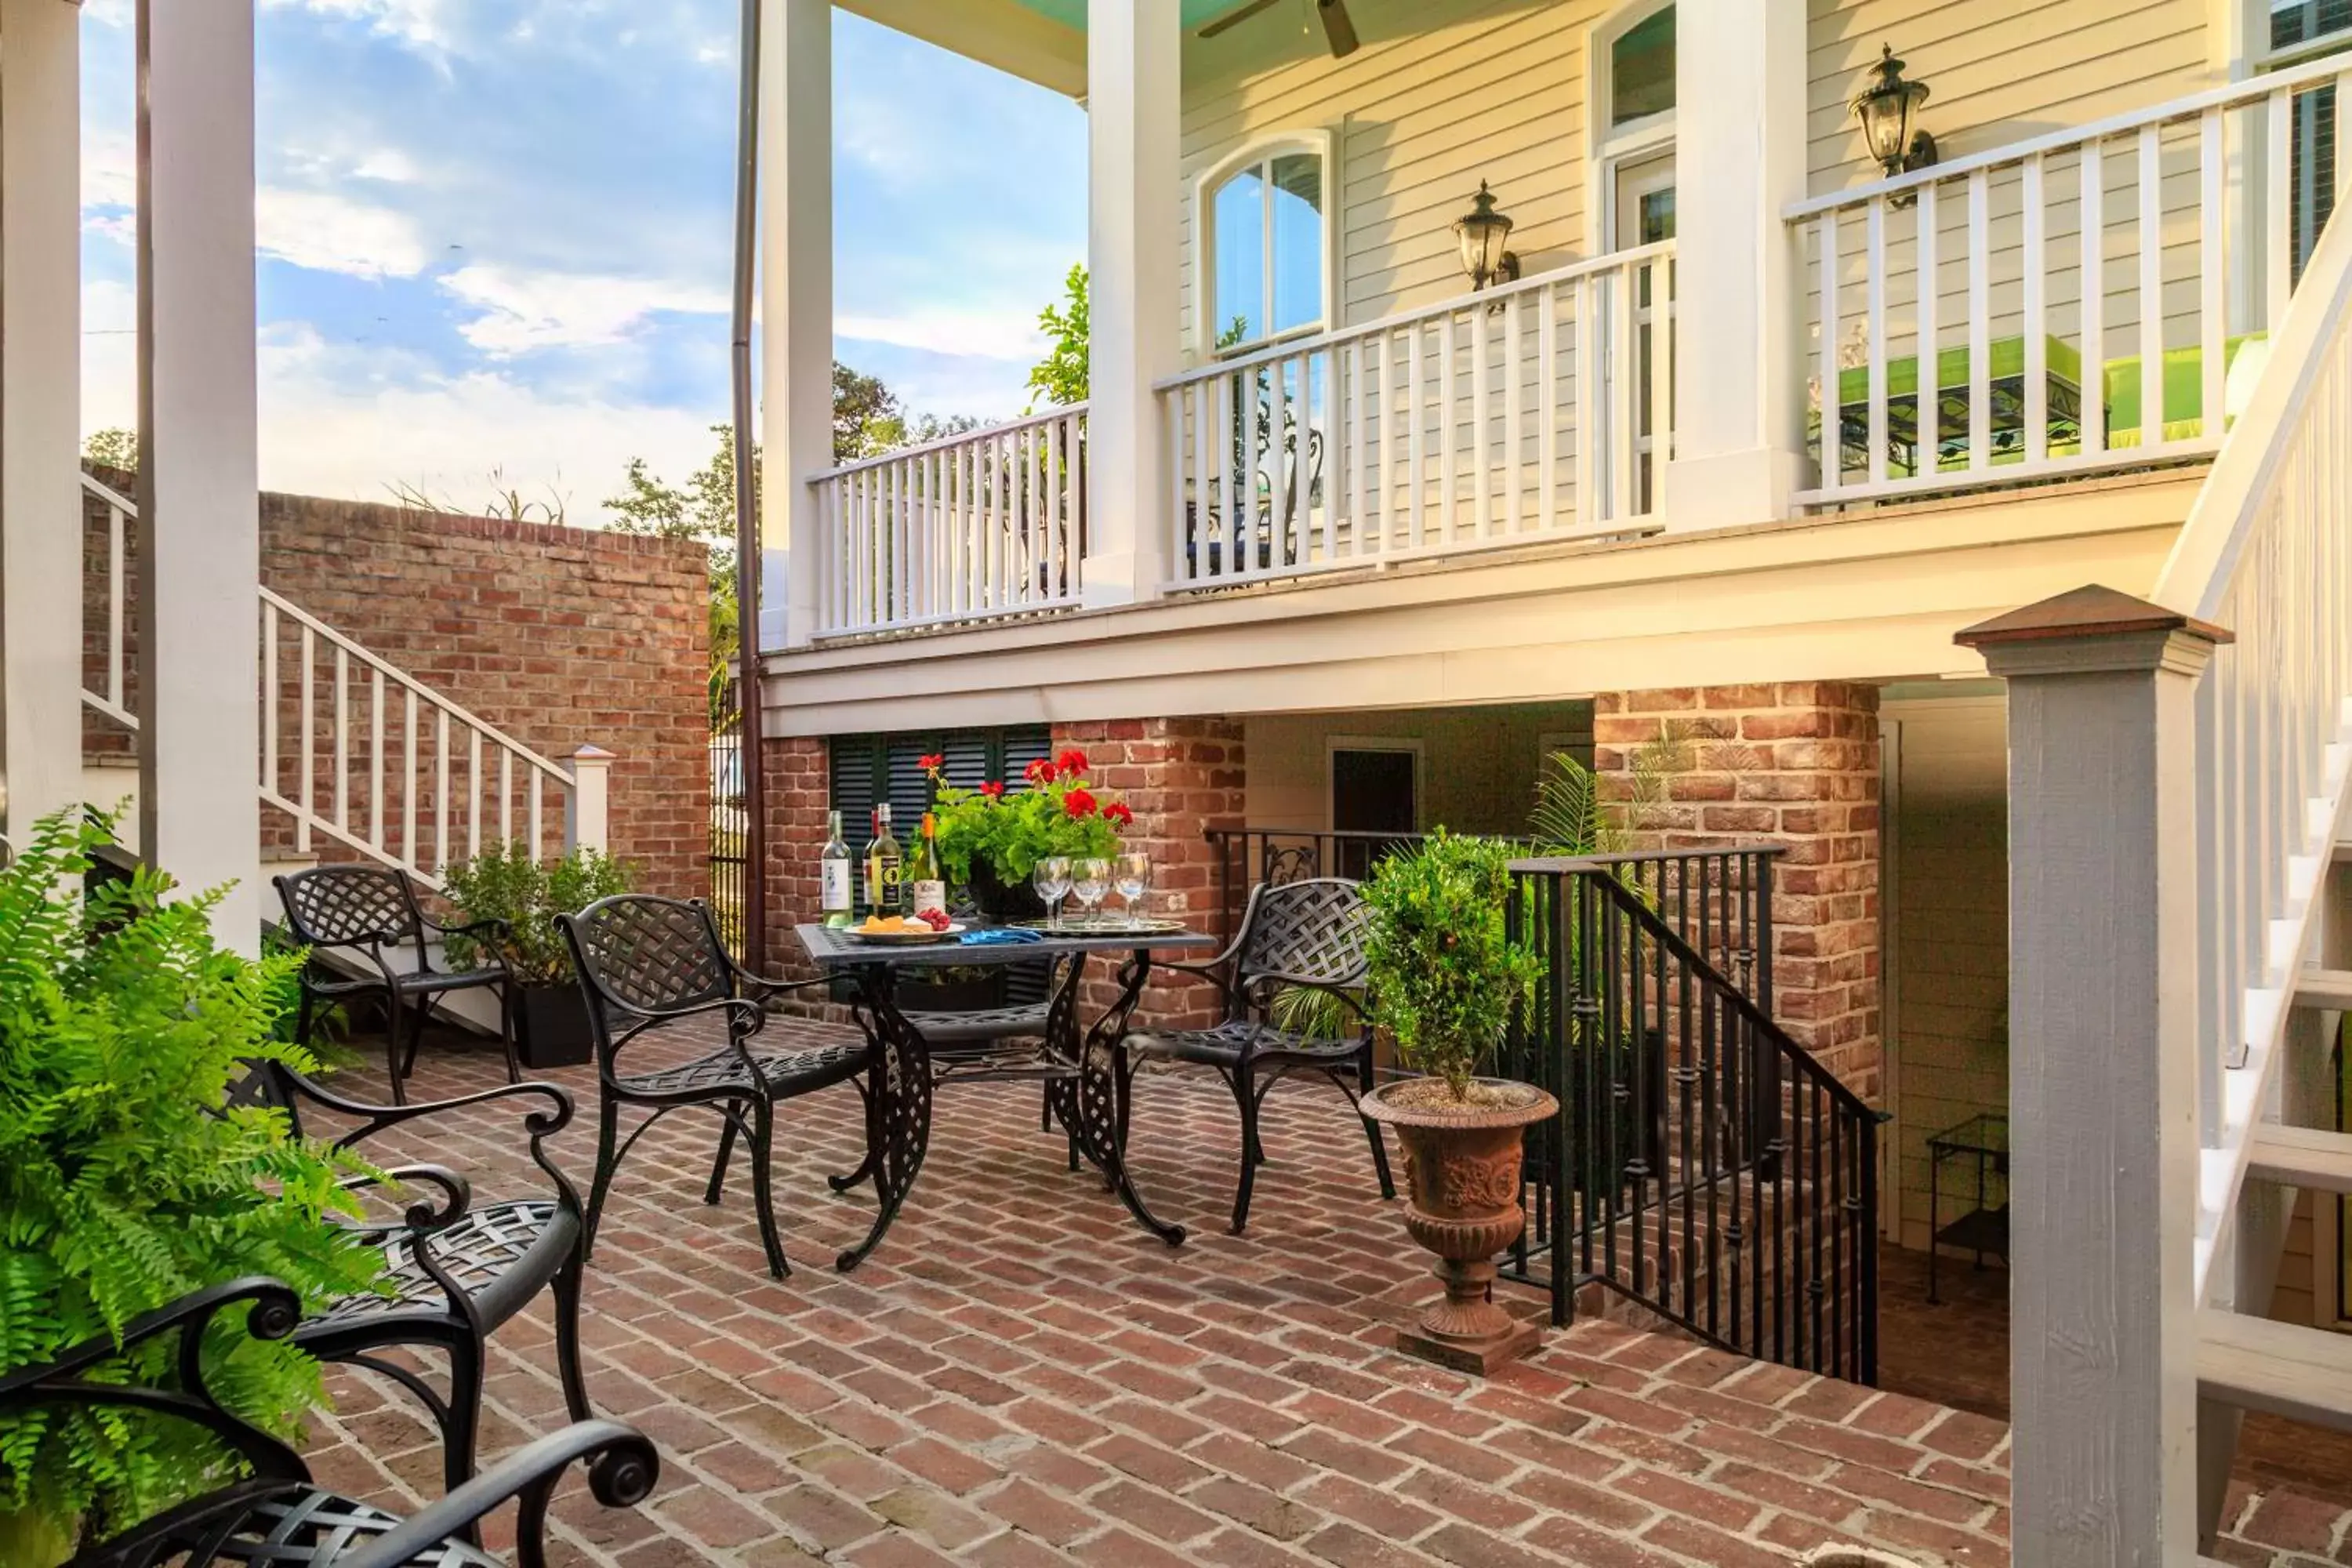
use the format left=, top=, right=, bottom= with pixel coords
left=757, top=0, right=833, bottom=652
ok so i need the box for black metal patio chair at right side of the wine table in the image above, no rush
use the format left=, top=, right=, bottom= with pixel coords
left=1120, top=877, right=1397, bottom=1234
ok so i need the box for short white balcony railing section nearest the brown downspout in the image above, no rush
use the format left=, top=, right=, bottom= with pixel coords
left=809, top=402, right=1087, bottom=637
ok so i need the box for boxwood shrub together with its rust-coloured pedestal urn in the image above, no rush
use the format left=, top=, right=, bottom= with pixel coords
left=1364, top=827, right=1559, bottom=1373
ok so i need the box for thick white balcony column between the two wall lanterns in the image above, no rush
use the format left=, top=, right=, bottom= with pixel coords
left=1665, top=0, right=1806, bottom=529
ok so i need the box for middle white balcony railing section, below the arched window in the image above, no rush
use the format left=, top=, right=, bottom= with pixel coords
left=1157, top=242, right=1675, bottom=593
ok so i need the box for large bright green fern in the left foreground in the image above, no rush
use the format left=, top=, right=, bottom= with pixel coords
left=0, top=813, right=383, bottom=1568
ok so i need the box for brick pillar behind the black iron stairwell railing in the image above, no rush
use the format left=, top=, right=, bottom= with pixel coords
left=1592, top=682, right=1884, bottom=1100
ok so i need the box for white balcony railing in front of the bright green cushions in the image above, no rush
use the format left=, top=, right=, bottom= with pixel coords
left=1785, top=56, right=2352, bottom=506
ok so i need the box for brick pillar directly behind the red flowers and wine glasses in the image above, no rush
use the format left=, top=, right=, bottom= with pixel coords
left=1054, top=720, right=1249, bottom=1027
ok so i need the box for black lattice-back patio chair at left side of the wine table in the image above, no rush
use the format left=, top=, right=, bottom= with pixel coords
left=555, top=893, right=875, bottom=1279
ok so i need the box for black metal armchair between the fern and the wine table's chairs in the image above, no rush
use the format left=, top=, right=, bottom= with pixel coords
left=230, top=1060, right=593, bottom=1490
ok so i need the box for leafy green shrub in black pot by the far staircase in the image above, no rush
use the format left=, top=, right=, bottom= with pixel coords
left=442, top=839, right=633, bottom=1072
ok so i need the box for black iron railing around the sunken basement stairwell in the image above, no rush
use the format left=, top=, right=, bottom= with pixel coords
left=1503, top=848, right=1877, bottom=1382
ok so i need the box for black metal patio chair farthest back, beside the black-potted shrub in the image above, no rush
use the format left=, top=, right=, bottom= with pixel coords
left=273, top=865, right=522, bottom=1105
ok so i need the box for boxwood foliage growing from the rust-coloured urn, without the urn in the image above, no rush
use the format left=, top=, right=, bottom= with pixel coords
left=1364, top=827, right=1538, bottom=1102
